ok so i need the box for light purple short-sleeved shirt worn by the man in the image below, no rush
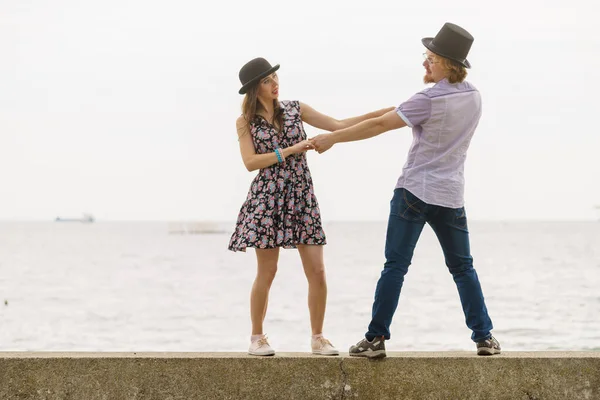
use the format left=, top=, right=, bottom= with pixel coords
left=396, top=79, right=481, bottom=208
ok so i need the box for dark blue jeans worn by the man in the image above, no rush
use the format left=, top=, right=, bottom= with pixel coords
left=365, top=188, right=493, bottom=342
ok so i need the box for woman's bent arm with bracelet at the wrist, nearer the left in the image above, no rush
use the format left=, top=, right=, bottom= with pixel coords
left=235, top=117, right=314, bottom=172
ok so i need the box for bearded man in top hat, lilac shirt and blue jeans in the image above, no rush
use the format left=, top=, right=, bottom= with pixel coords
left=312, top=23, right=500, bottom=358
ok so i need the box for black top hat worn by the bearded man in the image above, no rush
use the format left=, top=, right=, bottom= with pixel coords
left=421, top=22, right=474, bottom=68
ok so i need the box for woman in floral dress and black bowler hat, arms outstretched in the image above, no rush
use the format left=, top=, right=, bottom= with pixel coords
left=229, top=58, right=393, bottom=356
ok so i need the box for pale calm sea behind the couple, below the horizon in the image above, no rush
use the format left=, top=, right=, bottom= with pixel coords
left=0, top=221, right=600, bottom=352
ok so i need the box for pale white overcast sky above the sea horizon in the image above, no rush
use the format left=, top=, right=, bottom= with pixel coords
left=0, top=0, right=600, bottom=221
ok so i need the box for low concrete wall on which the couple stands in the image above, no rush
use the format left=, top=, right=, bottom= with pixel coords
left=0, top=352, right=600, bottom=400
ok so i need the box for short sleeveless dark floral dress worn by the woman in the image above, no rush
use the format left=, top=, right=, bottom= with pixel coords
left=228, top=101, right=326, bottom=251
